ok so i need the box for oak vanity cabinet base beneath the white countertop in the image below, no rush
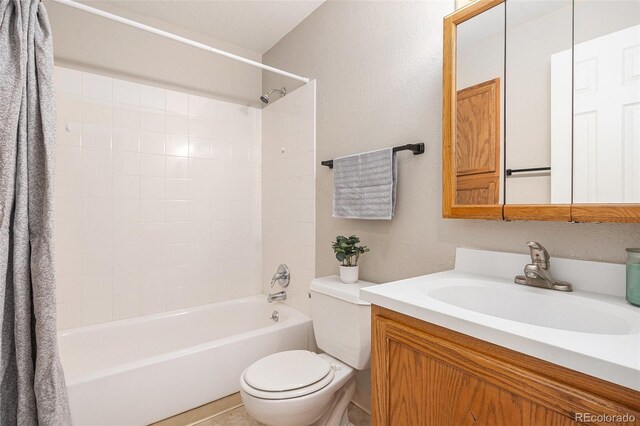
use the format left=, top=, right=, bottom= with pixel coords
left=371, top=306, right=640, bottom=426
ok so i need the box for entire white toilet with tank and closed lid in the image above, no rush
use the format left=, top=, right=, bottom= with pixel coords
left=240, top=277, right=372, bottom=426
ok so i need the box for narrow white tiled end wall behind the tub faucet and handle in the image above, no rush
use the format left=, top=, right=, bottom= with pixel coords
left=262, top=82, right=316, bottom=315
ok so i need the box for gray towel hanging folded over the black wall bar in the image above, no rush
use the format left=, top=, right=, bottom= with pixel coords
left=333, top=148, right=397, bottom=220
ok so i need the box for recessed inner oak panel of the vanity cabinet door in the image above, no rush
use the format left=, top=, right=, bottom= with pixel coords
left=387, top=340, right=579, bottom=426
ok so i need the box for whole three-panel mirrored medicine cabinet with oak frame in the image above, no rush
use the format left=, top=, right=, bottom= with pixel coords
left=442, top=0, right=640, bottom=223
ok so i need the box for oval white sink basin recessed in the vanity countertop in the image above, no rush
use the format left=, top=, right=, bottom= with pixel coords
left=427, top=280, right=632, bottom=335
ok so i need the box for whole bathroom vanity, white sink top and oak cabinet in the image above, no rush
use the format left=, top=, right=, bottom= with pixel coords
left=361, top=249, right=640, bottom=425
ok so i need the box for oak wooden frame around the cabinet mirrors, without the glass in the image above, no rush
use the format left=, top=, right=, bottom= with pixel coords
left=442, top=0, right=640, bottom=223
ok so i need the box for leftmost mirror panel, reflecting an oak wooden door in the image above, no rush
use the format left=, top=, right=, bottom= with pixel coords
left=453, top=3, right=505, bottom=206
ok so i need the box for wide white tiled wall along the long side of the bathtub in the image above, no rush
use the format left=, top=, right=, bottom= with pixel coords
left=55, top=67, right=261, bottom=329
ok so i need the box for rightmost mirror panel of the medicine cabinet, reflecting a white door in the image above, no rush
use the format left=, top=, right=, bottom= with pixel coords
left=572, top=0, right=640, bottom=203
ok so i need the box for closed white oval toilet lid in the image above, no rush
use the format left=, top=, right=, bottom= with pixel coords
left=244, top=351, right=331, bottom=392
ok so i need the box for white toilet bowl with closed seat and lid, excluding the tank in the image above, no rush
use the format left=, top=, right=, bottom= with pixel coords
left=240, top=351, right=355, bottom=426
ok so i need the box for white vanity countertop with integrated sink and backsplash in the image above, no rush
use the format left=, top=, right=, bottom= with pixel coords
left=360, top=253, right=640, bottom=391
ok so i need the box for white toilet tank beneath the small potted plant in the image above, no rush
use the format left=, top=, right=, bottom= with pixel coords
left=310, top=276, right=374, bottom=370
